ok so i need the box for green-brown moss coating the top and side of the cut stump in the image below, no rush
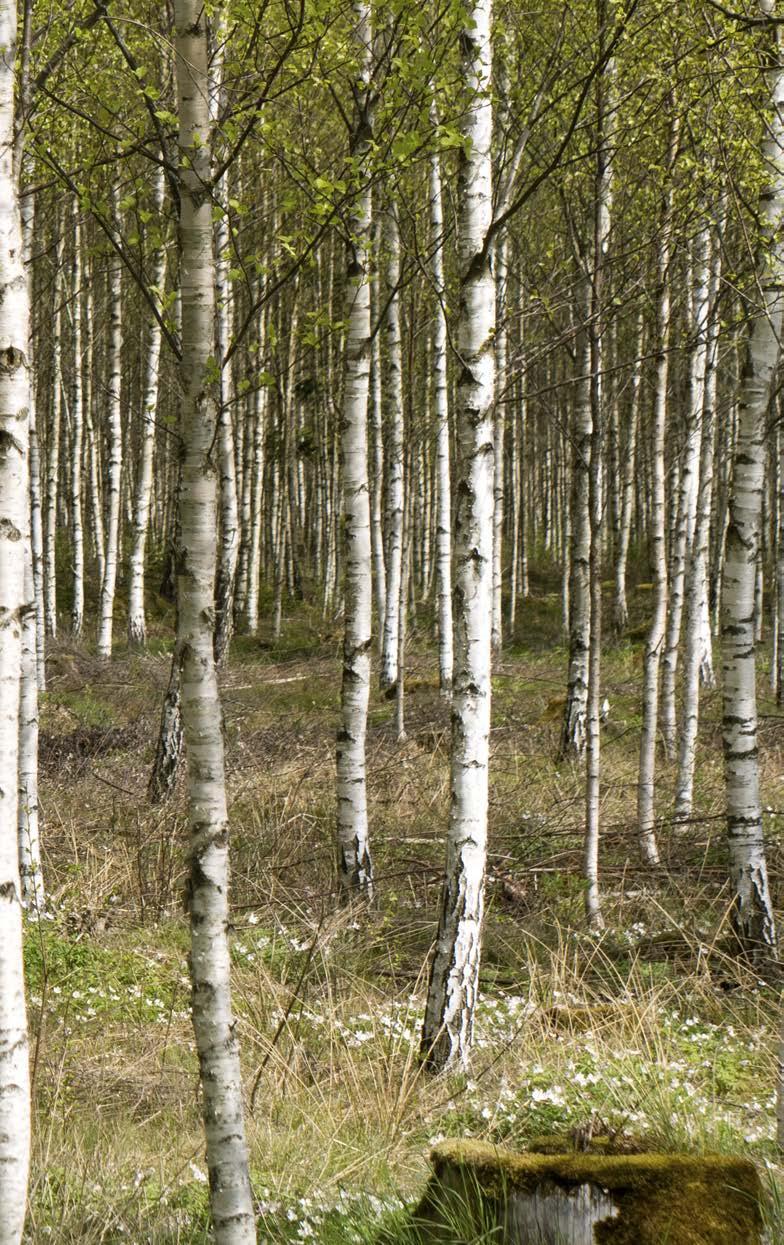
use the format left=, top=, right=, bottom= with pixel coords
left=418, top=1140, right=762, bottom=1245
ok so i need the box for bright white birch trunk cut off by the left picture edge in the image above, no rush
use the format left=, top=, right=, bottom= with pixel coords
left=0, top=0, right=35, bottom=1230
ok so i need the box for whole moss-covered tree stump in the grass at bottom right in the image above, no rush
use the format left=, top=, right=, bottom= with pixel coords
left=416, top=1142, right=764, bottom=1245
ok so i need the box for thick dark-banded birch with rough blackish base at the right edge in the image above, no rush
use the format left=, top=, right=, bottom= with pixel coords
left=722, top=0, right=784, bottom=957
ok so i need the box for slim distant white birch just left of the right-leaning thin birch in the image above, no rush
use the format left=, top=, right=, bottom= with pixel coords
left=97, top=211, right=122, bottom=657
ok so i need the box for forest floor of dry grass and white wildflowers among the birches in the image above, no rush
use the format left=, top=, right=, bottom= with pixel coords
left=26, top=570, right=784, bottom=1245
